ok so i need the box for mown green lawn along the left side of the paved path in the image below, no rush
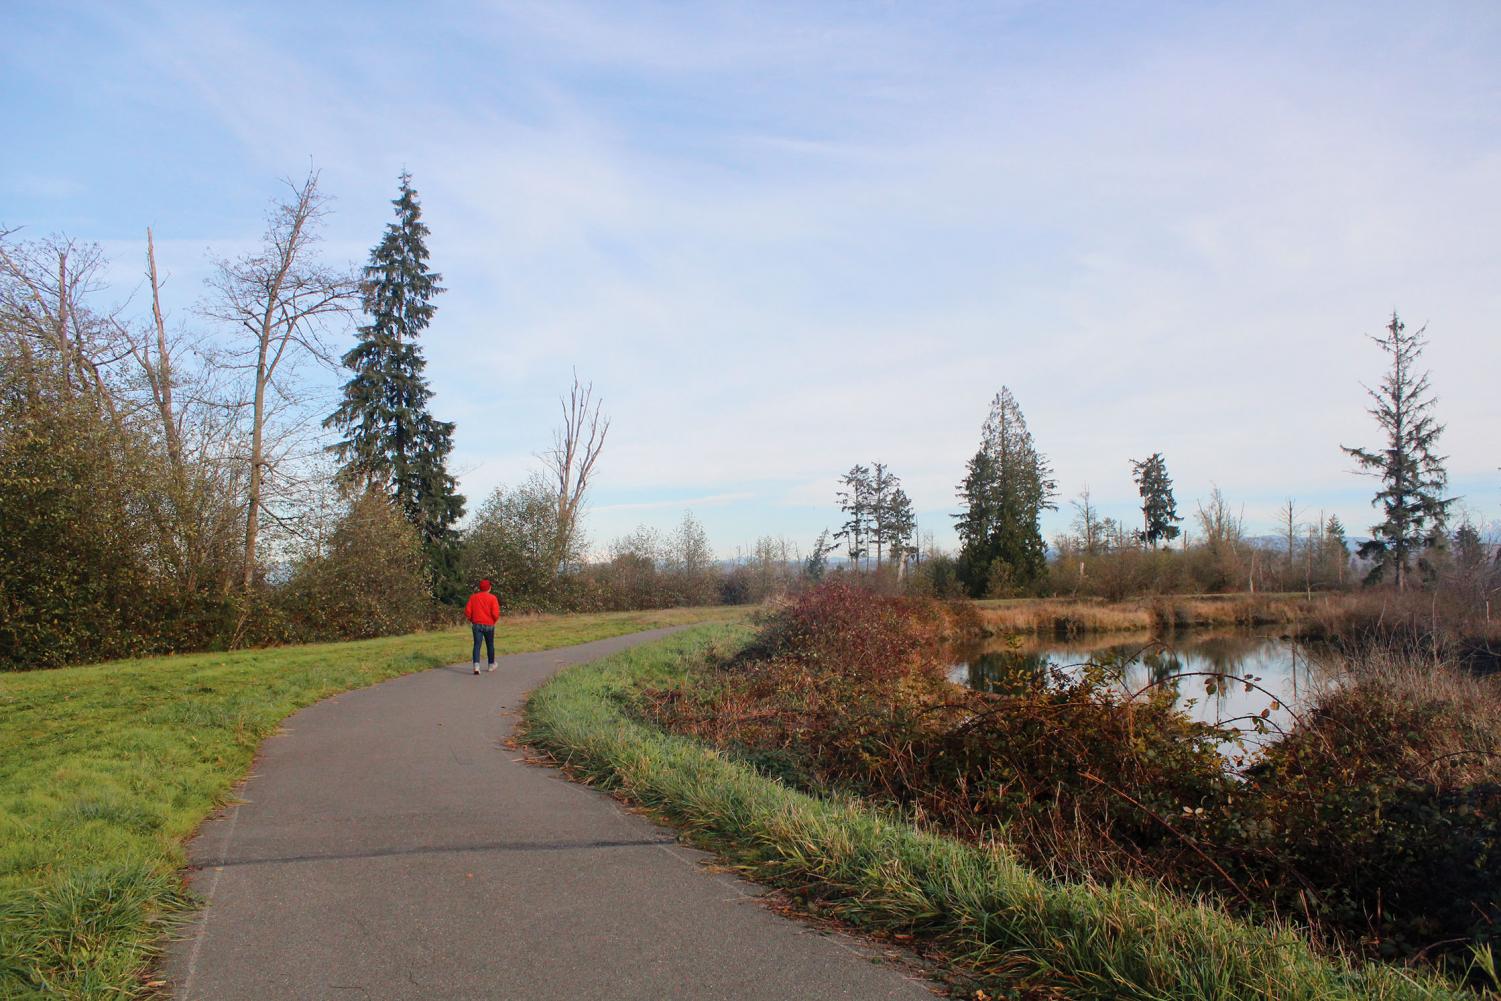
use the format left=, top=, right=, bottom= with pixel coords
left=0, top=609, right=735, bottom=998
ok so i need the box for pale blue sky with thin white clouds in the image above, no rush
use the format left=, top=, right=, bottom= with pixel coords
left=0, top=0, right=1501, bottom=554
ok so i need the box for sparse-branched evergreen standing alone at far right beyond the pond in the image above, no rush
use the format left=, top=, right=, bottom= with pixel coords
left=1340, top=312, right=1453, bottom=590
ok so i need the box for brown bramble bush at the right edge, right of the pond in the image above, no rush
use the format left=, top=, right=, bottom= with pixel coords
left=1219, top=656, right=1501, bottom=956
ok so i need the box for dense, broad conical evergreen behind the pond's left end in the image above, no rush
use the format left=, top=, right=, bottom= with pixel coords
left=955, top=386, right=1057, bottom=597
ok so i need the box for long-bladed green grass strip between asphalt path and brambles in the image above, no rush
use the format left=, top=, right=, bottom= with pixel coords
left=527, top=626, right=1474, bottom=1001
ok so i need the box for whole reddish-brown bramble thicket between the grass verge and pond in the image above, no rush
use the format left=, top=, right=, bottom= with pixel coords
left=636, top=579, right=1501, bottom=957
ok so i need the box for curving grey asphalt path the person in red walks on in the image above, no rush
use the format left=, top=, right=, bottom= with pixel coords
left=167, top=630, right=932, bottom=1001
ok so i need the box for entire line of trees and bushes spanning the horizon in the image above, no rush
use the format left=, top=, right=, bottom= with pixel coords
left=0, top=164, right=1501, bottom=669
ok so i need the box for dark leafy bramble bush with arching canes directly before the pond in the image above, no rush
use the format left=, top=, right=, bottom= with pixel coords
left=894, top=663, right=1231, bottom=876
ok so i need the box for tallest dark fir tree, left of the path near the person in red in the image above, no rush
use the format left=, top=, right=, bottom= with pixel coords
left=324, top=171, right=464, bottom=600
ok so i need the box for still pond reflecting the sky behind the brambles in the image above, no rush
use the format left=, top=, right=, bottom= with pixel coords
left=949, top=627, right=1325, bottom=746
